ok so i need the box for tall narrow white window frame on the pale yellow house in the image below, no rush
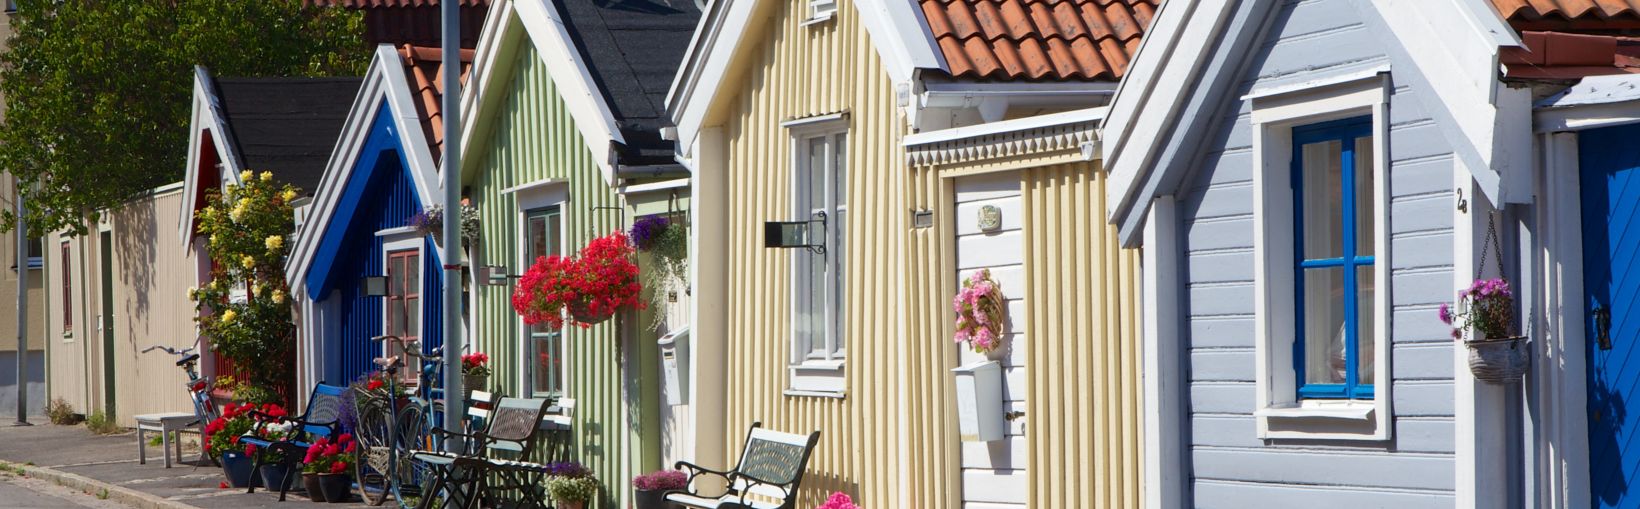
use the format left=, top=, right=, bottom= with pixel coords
left=782, top=113, right=853, bottom=397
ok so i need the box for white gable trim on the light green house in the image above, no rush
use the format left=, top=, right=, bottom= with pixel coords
left=461, top=0, right=626, bottom=186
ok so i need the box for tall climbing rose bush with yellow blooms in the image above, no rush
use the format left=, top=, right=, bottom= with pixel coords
left=189, top=171, right=297, bottom=392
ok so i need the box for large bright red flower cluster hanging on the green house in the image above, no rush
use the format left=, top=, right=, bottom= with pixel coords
left=513, top=232, right=645, bottom=328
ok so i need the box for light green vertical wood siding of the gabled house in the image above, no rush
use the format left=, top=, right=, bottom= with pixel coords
left=467, top=43, right=646, bottom=507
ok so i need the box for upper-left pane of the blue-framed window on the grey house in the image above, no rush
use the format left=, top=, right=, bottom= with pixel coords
left=1299, top=140, right=1343, bottom=259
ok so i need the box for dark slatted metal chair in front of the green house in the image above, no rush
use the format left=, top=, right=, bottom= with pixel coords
left=415, top=397, right=546, bottom=507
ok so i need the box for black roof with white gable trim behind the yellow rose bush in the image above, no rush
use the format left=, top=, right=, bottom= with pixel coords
left=177, top=67, right=361, bottom=245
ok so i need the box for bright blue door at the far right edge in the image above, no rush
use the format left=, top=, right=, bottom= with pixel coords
left=1578, top=125, right=1640, bottom=507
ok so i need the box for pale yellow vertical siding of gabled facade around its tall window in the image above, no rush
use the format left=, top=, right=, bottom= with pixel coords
left=702, top=0, right=911, bottom=507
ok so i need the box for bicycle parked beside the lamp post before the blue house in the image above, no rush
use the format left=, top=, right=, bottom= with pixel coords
left=354, top=335, right=443, bottom=509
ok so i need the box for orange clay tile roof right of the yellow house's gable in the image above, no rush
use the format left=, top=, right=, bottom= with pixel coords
left=918, top=0, right=1154, bottom=80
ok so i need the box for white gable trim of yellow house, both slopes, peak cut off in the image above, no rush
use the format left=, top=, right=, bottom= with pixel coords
left=666, top=0, right=948, bottom=156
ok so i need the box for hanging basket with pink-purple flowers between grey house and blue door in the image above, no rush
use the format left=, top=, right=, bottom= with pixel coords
left=1438, top=277, right=1530, bottom=384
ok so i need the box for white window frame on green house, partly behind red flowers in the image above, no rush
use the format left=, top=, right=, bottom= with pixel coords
left=502, top=179, right=574, bottom=397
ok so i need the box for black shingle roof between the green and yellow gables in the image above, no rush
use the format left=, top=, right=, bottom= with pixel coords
left=558, top=0, right=700, bottom=166
